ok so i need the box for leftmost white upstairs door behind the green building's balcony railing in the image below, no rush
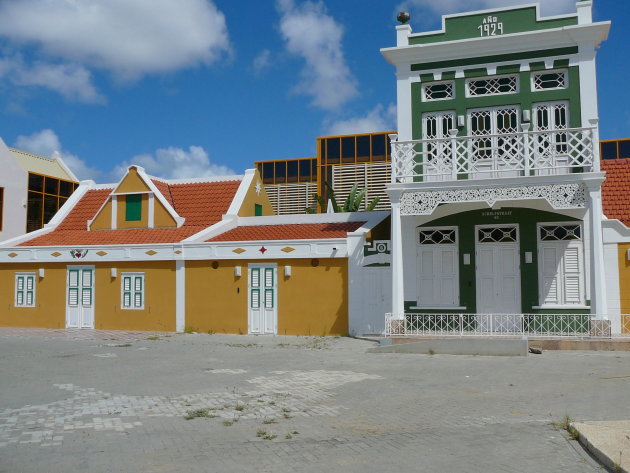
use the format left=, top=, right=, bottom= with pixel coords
left=422, top=112, right=456, bottom=181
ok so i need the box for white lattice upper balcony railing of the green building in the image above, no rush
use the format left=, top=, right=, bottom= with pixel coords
left=392, top=128, right=599, bottom=183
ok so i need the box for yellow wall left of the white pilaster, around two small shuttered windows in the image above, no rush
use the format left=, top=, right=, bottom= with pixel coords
left=0, top=261, right=175, bottom=331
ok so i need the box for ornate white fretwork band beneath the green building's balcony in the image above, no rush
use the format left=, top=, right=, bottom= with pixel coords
left=400, top=184, right=587, bottom=215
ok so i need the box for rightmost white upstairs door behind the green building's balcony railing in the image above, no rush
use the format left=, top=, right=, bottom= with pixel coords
left=532, top=102, right=572, bottom=176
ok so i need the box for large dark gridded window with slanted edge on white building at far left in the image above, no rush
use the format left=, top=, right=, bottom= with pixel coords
left=26, top=172, right=77, bottom=232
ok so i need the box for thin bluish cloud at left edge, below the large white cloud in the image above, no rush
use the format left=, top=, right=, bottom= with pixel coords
left=0, top=56, right=105, bottom=103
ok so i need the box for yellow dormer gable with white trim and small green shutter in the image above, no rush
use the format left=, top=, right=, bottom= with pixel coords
left=88, top=166, right=183, bottom=230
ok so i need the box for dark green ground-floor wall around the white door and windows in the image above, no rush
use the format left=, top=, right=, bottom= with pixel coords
left=405, top=207, right=588, bottom=314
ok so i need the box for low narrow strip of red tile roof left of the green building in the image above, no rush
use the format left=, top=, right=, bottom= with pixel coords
left=207, top=222, right=365, bottom=241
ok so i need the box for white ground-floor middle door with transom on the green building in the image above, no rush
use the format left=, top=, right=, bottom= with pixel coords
left=476, top=226, right=521, bottom=331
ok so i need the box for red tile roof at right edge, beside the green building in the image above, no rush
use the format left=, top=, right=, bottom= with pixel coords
left=602, top=158, right=630, bottom=226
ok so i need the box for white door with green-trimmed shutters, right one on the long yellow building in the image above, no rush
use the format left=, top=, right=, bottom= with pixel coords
left=248, top=264, right=278, bottom=334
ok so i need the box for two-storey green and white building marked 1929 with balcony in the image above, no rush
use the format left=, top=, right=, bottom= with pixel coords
left=381, top=1, right=610, bottom=333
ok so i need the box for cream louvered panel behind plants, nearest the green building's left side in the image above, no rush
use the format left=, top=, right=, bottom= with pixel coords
left=332, top=163, right=391, bottom=210
